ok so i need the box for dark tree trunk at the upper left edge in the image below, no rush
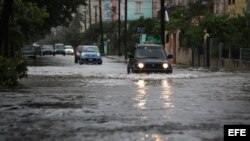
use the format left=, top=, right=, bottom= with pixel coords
left=0, top=0, right=14, bottom=57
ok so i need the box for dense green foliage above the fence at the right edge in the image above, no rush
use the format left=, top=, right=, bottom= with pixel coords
left=200, top=14, right=250, bottom=48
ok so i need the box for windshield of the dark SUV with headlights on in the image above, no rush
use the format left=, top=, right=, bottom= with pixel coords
left=135, top=46, right=167, bottom=59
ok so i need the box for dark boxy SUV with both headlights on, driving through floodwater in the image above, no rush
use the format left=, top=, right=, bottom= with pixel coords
left=127, top=44, right=172, bottom=74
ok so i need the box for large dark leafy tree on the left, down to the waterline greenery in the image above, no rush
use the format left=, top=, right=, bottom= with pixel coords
left=0, top=0, right=85, bottom=88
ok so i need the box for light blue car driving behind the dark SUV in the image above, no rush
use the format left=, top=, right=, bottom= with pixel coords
left=79, top=45, right=102, bottom=64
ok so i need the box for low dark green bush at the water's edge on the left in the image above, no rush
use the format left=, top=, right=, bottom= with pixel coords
left=0, top=55, right=28, bottom=90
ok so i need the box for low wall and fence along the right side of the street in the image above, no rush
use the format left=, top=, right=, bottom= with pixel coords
left=176, top=38, right=250, bottom=71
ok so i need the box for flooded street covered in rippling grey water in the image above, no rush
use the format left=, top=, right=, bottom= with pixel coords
left=0, top=55, right=250, bottom=141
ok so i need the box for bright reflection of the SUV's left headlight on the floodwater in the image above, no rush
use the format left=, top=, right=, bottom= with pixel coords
left=135, top=80, right=147, bottom=109
